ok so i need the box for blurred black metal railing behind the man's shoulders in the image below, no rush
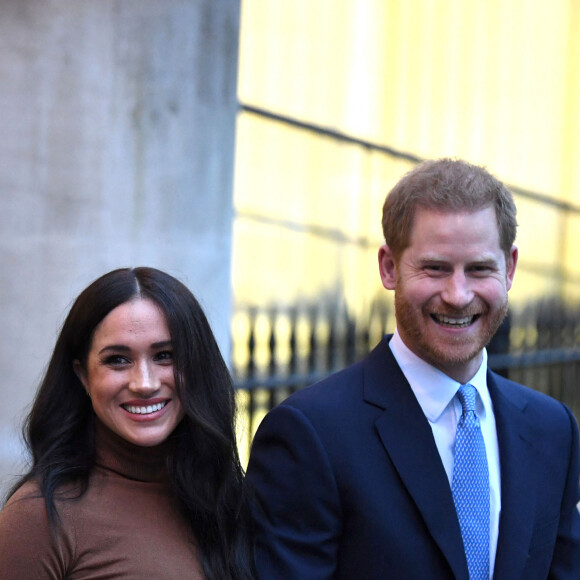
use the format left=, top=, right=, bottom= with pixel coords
left=233, top=300, right=580, bottom=458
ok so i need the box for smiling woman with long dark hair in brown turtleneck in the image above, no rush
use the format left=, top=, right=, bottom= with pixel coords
left=0, top=268, right=252, bottom=580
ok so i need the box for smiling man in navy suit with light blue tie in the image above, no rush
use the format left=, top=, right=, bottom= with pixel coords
left=248, top=159, right=580, bottom=580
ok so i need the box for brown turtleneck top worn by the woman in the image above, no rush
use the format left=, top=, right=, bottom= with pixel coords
left=0, top=424, right=203, bottom=580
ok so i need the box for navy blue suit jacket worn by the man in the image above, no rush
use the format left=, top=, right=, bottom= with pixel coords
left=247, top=337, right=580, bottom=580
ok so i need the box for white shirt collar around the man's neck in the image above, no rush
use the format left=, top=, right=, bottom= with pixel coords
left=389, top=330, right=491, bottom=423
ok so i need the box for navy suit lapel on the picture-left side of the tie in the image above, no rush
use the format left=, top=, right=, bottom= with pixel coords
left=364, top=337, right=468, bottom=580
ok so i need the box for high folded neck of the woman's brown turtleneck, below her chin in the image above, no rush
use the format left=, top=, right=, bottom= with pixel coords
left=95, top=419, right=173, bottom=482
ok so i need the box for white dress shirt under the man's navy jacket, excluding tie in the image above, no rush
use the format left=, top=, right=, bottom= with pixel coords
left=389, top=331, right=501, bottom=578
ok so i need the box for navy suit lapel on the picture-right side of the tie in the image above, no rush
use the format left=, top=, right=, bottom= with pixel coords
left=487, top=372, right=537, bottom=580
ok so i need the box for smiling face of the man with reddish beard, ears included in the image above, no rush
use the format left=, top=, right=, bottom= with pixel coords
left=379, top=207, right=517, bottom=383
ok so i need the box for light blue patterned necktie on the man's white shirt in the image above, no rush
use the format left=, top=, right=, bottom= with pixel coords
left=451, top=385, right=489, bottom=580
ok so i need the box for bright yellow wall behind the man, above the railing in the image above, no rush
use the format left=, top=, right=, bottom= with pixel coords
left=234, top=0, right=580, bottom=313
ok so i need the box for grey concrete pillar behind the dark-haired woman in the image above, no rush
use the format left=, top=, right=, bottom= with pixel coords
left=0, top=0, right=240, bottom=492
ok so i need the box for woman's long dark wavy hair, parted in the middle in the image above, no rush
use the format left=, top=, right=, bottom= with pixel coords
left=11, top=267, right=253, bottom=580
